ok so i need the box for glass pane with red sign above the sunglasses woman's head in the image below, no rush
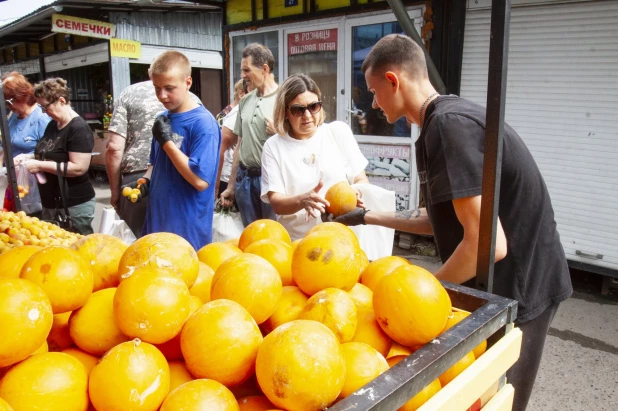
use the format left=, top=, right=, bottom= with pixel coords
left=287, top=29, right=338, bottom=122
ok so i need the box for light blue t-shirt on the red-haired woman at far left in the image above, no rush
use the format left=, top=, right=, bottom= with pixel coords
left=9, top=105, right=51, bottom=157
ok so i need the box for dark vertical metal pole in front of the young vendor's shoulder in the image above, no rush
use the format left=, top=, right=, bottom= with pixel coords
left=476, top=0, right=511, bottom=292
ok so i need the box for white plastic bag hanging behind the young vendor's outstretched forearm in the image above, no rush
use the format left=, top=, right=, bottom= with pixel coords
left=350, top=184, right=395, bottom=261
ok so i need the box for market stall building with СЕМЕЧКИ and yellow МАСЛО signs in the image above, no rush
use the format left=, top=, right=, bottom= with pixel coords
left=0, top=0, right=223, bottom=177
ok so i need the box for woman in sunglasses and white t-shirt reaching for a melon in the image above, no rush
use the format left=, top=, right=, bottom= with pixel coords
left=261, top=74, right=369, bottom=240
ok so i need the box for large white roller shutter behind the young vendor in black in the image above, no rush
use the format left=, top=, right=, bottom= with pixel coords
left=461, top=0, right=618, bottom=270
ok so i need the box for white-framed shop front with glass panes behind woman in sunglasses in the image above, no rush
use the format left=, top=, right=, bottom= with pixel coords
left=224, top=1, right=434, bottom=210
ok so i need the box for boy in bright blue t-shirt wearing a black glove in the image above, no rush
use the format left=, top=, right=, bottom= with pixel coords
left=134, top=51, right=221, bottom=250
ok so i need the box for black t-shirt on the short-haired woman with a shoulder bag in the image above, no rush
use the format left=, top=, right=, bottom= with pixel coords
left=34, top=117, right=94, bottom=209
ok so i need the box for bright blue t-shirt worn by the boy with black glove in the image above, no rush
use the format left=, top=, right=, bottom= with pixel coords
left=142, top=106, right=221, bottom=250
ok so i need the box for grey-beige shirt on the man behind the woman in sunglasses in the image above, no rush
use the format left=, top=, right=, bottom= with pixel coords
left=234, top=90, right=277, bottom=168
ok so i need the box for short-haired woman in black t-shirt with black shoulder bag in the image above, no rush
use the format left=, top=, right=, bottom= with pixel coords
left=26, top=78, right=95, bottom=235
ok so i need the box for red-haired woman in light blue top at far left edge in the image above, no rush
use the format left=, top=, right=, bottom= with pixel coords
left=2, top=71, right=51, bottom=165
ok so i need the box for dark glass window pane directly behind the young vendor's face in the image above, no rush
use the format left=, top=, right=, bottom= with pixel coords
left=352, top=22, right=411, bottom=137
